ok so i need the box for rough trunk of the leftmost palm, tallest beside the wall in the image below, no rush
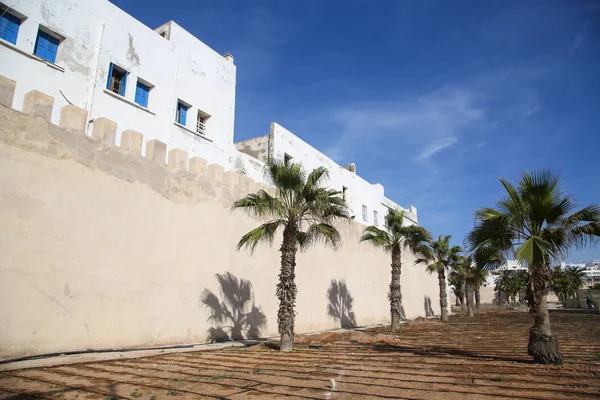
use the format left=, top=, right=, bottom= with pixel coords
left=277, top=225, right=298, bottom=351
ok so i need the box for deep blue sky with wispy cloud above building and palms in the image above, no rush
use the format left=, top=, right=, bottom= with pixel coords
left=113, top=0, right=600, bottom=261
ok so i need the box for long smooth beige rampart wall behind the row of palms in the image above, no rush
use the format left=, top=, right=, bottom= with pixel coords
left=0, top=89, right=439, bottom=358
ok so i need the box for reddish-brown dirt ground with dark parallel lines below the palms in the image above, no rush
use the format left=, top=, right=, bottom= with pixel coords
left=0, top=311, right=600, bottom=400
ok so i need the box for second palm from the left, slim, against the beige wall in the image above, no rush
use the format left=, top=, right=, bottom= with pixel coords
left=360, top=208, right=430, bottom=332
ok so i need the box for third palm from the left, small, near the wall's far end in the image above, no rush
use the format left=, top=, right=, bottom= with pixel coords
left=416, top=235, right=462, bottom=321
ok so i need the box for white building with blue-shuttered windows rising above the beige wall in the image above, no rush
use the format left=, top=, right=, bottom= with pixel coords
left=0, top=0, right=417, bottom=225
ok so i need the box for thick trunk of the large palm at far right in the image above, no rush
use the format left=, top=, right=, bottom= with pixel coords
left=527, top=264, right=563, bottom=364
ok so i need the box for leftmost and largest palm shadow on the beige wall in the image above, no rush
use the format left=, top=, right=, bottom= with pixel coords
left=200, top=272, right=267, bottom=343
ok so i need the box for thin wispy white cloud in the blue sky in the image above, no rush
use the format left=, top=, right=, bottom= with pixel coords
left=327, top=86, right=485, bottom=161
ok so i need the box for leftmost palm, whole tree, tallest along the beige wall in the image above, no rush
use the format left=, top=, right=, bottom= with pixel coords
left=233, top=161, right=348, bottom=351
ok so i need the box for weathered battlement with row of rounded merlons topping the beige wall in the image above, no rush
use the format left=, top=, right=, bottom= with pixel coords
left=0, top=76, right=269, bottom=202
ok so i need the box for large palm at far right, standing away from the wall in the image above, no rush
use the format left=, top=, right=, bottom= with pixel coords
left=467, top=170, right=600, bottom=363
